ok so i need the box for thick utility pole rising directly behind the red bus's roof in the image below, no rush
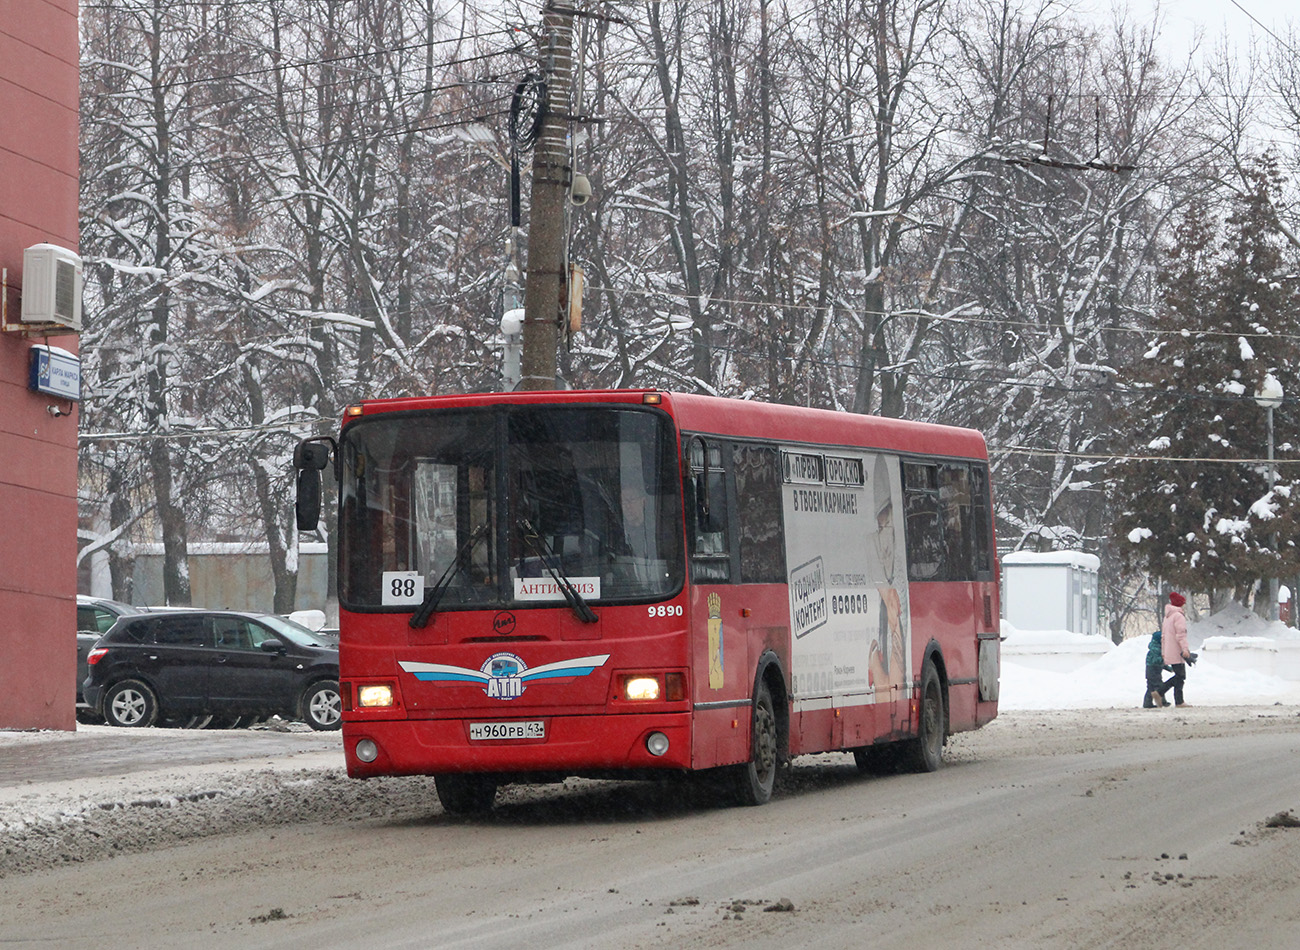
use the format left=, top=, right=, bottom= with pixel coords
left=519, top=0, right=573, bottom=390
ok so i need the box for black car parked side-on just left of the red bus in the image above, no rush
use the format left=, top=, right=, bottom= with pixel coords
left=82, top=611, right=342, bottom=729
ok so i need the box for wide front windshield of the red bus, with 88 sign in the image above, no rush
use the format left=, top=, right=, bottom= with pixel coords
left=339, top=405, right=684, bottom=611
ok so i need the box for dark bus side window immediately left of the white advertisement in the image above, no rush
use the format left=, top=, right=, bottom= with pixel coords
left=732, top=443, right=785, bottom=584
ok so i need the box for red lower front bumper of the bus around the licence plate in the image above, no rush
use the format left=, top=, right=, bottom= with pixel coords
left=343, top=712, right=690, bottom=778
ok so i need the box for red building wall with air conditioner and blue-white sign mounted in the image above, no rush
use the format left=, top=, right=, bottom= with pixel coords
left=0, top=0, right=78, bottom=729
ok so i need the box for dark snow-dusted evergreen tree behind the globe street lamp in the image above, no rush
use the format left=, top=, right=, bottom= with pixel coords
left=1115, top=157, right=1300, bottom=603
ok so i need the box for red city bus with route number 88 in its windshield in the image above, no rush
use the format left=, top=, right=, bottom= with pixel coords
left=294, top=390, right=1000, bottom=814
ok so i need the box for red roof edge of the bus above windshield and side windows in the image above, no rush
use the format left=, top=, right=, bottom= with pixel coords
left=350, top=390, right=988, bottom=459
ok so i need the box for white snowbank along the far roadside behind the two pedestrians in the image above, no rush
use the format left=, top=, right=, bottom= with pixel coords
left=1000, top=606, right=1300, bottom=710
